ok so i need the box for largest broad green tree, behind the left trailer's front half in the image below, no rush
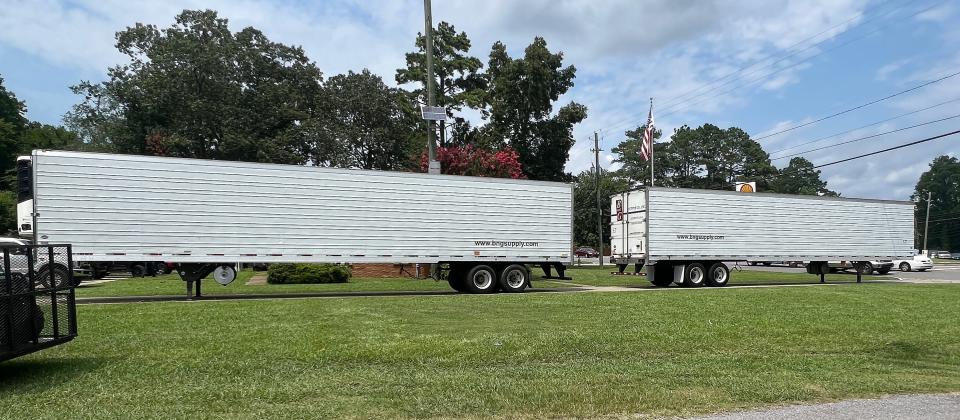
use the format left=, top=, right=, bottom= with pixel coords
left=67, top=10, right=322, bottom=163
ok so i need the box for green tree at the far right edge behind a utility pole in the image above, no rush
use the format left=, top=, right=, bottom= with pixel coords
left=910, top=155, right=960, bottom=251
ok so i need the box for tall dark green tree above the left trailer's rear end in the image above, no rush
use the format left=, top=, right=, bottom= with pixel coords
left=485, top=37, right=587, bottom=180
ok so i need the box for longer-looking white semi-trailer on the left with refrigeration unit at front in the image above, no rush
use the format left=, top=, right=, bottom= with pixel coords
left=17, top=150, right=573, bottom=294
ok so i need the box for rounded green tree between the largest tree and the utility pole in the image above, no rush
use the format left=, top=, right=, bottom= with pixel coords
left=317, top=70, right=426, bottom=170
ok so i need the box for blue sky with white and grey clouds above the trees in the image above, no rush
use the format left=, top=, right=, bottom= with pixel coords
left=0, top=0, right=960, bottom=199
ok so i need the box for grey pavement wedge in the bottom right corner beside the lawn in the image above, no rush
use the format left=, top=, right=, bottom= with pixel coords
left=701, top=393, right=960, bottom=420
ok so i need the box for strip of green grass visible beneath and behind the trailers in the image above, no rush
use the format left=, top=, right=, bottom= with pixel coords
left=77, top=265, right=872, bottom=297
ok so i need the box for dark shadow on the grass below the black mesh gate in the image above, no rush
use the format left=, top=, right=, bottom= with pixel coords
left=0, top=357, right=109, bottom=394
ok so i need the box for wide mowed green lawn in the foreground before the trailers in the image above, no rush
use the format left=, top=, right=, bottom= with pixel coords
left=0, top=283, right=960, bottom=418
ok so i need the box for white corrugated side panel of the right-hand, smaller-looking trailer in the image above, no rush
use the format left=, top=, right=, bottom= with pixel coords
left=648, top=188, right=915, bottom=261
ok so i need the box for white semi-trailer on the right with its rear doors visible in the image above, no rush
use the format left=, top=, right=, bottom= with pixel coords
left=610, top=188, right=915, bottom=287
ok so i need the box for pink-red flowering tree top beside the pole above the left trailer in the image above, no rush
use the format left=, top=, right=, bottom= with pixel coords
left=420, top=145, right=526, bottom=179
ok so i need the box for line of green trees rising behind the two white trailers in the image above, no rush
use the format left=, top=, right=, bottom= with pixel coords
left=0, top=10, right=960, bottom=253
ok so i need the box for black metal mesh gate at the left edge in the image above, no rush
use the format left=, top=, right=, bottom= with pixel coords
left=0, top=245, right=77, bottom=361
